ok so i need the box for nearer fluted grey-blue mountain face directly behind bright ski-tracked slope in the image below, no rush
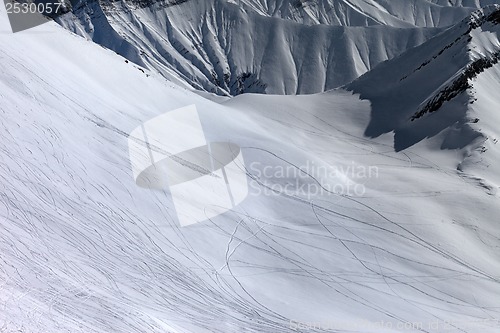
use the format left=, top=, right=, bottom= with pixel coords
left=60, top=0, right=442, bottom=96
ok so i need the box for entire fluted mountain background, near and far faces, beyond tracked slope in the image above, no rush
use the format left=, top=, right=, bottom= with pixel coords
left=53, top=0, right=496, bottom=96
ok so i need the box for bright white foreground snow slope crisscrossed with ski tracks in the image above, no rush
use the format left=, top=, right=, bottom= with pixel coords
left=0, top=4, right=500, bottom=333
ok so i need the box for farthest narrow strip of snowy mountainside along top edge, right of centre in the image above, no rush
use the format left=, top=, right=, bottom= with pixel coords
left=232, top=0, right=497, bottom=27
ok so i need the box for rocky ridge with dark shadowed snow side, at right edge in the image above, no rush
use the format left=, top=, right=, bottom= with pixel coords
left=347, top=5, right=500, bottom=186
